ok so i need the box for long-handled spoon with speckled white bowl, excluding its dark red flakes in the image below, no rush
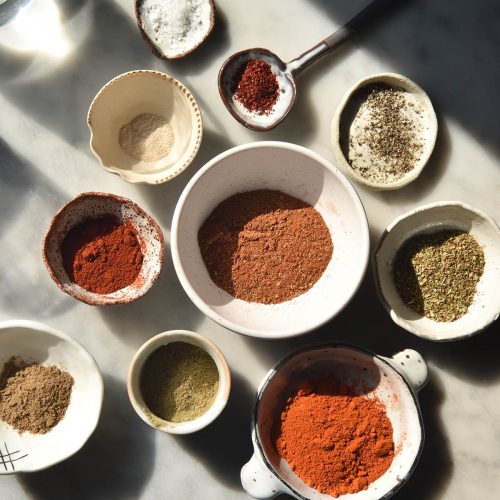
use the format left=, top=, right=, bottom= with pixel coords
left=218, top=0, right=398, bottom=131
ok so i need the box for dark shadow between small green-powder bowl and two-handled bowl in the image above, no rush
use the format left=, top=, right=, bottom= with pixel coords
left=175, top=371, right=255, bottom=491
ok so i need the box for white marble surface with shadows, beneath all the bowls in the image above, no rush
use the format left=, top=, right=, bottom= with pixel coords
left=0, top=0, right=500, bottom=500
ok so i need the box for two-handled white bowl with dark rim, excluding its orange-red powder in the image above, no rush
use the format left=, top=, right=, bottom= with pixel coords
left=241, top=342, right=428, bottom=500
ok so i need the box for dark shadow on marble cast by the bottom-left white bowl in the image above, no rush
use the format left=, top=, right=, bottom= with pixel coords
left=17, top=376, right=156, bottom=500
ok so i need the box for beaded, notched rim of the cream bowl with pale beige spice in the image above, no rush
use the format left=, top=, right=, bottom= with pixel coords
left=87, top=69, right=203, bottom=185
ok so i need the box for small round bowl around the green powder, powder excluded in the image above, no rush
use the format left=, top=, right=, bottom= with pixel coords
left=127, top=330, right=231, bottom=434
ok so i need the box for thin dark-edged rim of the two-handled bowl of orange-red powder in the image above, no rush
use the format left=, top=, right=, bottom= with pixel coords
left=251, top=341, right=425, bottom=500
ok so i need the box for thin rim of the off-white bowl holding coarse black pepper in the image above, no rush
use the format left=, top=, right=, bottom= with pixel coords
left=330, top=72, right=438, bottom=191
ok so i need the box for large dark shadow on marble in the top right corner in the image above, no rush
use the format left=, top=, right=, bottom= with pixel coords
left=310, top=0, right=500, bottom=156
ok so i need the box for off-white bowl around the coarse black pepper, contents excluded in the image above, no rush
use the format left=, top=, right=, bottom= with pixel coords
left=331, top=73, right=438, bottom=191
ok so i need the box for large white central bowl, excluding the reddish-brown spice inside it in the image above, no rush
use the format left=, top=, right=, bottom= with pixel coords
left=171, top=142, right=369, bottom=338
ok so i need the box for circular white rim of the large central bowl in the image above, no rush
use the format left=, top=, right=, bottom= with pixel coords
left=170, top=141, right=370, bottom=339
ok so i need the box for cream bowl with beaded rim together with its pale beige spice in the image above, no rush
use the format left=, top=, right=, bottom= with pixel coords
left=87, top=70, right=203, bottom=184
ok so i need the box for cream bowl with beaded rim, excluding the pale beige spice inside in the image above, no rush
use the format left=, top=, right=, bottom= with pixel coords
left=87, top=70, right=203, bottom=184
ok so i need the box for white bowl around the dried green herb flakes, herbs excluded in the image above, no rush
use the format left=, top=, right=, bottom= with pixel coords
left=372, top=201, right=500, bottom=341
